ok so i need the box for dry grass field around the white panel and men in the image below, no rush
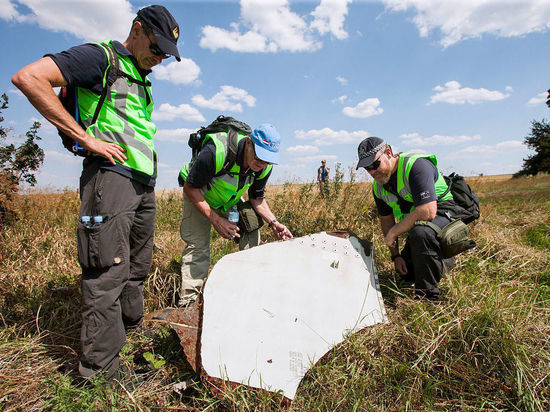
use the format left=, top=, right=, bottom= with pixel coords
left=0, top=175, right=550, bottom=411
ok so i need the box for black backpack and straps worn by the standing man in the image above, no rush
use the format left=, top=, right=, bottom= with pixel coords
left=57, top=44, right=151, bottom=157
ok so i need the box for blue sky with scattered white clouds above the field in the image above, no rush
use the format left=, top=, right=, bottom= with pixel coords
left=0, top=0, right=550, bottom=189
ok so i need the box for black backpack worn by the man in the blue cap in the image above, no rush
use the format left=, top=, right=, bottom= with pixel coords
left=188, top=115, right=252, bottom=176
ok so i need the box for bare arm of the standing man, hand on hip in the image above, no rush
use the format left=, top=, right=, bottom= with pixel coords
left=11, top=57, right=126, bottom=164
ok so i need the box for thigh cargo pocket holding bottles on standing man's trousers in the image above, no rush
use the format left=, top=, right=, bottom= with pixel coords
left=77, top=216, right=124, bottom=270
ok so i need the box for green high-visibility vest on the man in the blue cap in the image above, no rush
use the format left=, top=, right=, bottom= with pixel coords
left=180, top=132, right=273, bottom=213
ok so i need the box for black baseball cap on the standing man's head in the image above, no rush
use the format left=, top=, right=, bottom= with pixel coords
left=137, top=5, right=181, bottom=61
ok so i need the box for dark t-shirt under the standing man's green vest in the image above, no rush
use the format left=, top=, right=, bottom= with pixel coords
left=46, top=41, right=156, bottom=187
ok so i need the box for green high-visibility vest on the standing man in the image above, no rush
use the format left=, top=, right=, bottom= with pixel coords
left=78, top=42, right=157, bottom=177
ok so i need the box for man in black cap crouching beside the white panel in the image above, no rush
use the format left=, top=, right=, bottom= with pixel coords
left=357, top=136, right=464, bottom=300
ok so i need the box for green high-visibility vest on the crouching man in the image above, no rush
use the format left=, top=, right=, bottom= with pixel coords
left=372, top=153, right=453, bottom=221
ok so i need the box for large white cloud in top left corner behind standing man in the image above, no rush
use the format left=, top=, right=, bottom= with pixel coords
left=0, top=0, right=135, bottom=41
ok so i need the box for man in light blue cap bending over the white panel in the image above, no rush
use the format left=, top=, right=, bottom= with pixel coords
left=179, top=123, right=292, bottom=306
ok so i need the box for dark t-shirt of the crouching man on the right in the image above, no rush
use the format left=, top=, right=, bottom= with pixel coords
left=374, top=157, right=439, bottom=216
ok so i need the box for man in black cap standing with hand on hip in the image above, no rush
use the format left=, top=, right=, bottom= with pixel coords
left=12, top=6, right=180, bottom=379
